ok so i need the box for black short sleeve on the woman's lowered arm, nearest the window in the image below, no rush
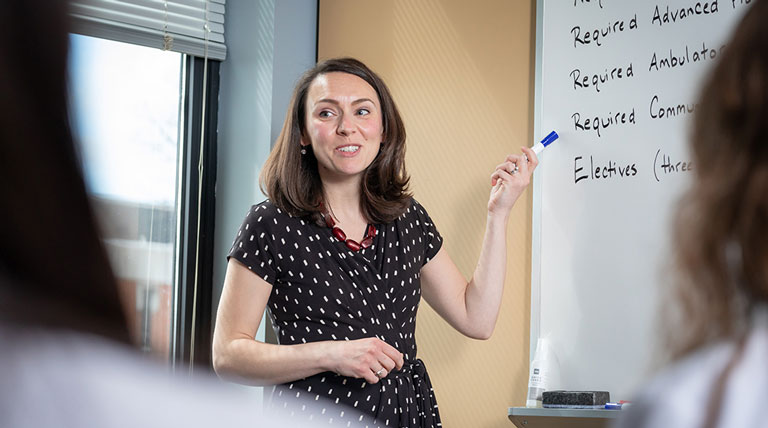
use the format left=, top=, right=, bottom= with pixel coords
left=227, top=202, right=277, bottom=285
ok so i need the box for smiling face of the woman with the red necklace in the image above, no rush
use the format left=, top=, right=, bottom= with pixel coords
left=302, top=72, right=384, bottom=182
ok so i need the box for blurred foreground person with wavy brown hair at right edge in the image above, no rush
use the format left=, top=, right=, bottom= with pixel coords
left=620, top=0, right=768, bottom=428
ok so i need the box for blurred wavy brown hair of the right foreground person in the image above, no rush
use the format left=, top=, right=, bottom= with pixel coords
left=665, top=1, right=768, bottom=358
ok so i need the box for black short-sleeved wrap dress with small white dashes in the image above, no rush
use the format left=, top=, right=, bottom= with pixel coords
left=229, top=200, right=442, bottom=428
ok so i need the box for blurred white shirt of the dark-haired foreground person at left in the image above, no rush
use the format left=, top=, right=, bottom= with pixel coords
left=0, top=324, right=356, bottom=428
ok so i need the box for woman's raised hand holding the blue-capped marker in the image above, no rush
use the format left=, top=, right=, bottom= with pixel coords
left=488, top=147, right=539, bottom=215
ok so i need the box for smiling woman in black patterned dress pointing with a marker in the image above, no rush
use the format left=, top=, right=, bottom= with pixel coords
left=213, top=58, right=538, bottom=427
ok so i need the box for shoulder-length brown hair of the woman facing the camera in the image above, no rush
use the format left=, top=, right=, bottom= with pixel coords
left=260, top=58, right=411, bottom=225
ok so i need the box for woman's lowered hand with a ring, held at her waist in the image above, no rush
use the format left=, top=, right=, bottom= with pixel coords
left=326, top=337, right=404, bottom=383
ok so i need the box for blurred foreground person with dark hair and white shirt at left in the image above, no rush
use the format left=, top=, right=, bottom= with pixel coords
left=0, top=0, right=356, bottom=428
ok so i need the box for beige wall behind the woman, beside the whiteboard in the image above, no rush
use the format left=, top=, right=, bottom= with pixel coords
left=318, top=0, right=535, bottom=428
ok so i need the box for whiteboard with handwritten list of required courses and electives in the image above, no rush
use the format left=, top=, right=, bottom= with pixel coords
left=531, top=0, right=749, bottom=400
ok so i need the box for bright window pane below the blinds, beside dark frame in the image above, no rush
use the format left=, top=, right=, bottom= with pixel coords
left=69, top=35, right=184, bottom=358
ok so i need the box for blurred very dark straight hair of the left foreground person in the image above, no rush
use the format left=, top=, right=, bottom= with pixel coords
left=0, top=0, right=130, bottom=343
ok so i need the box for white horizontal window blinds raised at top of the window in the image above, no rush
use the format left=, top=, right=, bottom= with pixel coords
left=70, top=0, right=227, bottom=60
